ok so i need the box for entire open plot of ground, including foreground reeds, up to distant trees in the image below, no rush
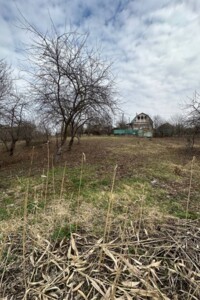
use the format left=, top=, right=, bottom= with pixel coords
left=0, top=137, right=200, bottom=299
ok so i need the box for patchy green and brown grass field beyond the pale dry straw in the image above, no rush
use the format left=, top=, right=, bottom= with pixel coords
left=0, top=137, right=200, bottom=225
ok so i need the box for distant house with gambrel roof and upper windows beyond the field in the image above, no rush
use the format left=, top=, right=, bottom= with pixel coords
left=129, top=113, right=153, bottom=137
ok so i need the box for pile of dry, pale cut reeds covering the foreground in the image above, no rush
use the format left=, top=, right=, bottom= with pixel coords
left=0, top=219, right=200, bottom=300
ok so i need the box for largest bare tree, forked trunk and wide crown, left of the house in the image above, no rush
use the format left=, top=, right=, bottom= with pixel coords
left=23, top=25, right=116, bottom=152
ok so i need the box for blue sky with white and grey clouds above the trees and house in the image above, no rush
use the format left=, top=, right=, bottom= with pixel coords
left=0, top=0, right=200, bottom=119
